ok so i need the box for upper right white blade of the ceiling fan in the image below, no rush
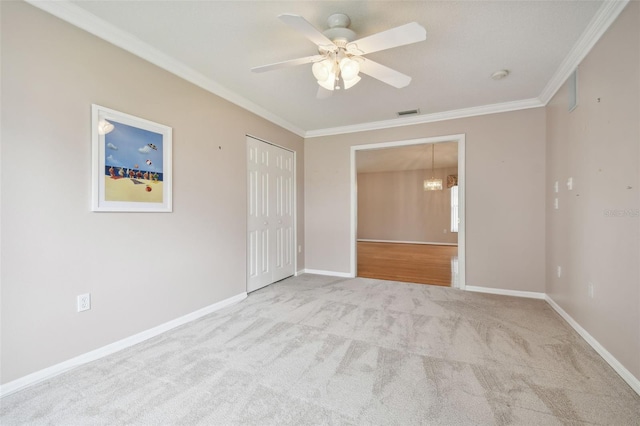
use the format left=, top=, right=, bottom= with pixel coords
left=347, top=22, right=427, bottom=55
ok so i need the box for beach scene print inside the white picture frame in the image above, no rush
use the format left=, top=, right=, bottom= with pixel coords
left=104, top=120, right=164, bottom=203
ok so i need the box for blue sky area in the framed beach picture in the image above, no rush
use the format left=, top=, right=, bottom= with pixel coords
left=104, top=120, right=163, bottom=173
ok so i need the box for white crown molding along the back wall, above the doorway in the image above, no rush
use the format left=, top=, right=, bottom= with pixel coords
left=305, top=98, right=544, bottom=138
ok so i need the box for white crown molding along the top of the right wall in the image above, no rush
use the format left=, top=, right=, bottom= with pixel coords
left=538, top=0, right=629, bottom=105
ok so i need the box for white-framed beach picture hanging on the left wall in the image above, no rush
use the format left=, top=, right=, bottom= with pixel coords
left=91, top=104, right=172, bottom=212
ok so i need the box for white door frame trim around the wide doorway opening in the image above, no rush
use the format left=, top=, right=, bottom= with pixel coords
left=349, top=133, right=466, bottom=290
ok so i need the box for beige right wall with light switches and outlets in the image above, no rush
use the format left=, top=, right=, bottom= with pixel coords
left=546, top=2, right=640, bottom=378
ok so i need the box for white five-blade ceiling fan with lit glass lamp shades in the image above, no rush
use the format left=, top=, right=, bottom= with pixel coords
left=251, top=13, right=427, bottom=97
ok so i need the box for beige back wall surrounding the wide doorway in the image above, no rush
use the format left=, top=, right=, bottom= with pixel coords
left=305, top=108, right=545, bottom=292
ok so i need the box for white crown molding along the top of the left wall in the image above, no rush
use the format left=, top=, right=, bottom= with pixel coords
left=26, top=0, right=305, bottom=137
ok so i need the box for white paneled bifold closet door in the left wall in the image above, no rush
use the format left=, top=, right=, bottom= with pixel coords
left=247, top=137, right=295, bottom=292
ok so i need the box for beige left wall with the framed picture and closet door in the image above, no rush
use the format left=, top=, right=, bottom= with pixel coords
left=0, top=2, right=304, bottom=383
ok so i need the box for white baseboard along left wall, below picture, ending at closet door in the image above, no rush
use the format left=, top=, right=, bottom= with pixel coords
left=0, top=292, right=247, bottom=398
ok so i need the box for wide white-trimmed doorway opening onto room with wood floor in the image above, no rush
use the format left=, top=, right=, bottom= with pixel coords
left=350, top=135, right=465, bottom=289
